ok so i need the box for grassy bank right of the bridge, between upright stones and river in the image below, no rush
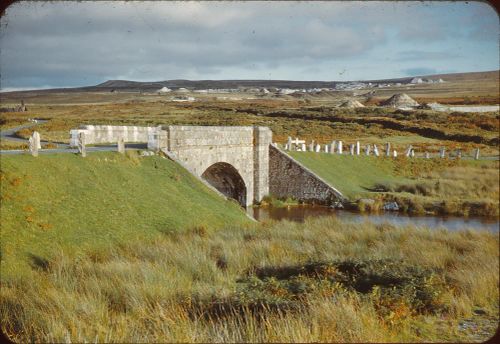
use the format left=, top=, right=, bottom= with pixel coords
left=289, top=152, right=500, bottom=217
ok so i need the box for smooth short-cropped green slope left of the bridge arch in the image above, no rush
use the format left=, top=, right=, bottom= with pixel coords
left=0, top=152, right=250, bottom=279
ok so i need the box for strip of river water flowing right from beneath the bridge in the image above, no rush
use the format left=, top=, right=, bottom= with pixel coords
left=249, top=205, right=500, bottom=233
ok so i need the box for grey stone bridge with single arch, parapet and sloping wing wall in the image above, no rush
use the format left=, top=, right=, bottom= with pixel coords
left=70, top=125, right=343, bottom=207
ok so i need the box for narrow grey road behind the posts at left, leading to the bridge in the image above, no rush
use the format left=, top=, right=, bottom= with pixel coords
left=0, top=120, right=147, bottom=155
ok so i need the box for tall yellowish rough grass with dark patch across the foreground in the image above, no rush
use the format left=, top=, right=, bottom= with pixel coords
left=0, top=218, right=499, bottom=342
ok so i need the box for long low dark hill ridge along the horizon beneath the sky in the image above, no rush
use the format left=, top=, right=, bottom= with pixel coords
left=1, top=71, right=499, bottom=94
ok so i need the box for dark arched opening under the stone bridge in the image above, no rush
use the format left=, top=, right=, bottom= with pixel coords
left=201, top=162, right=247, bottom=207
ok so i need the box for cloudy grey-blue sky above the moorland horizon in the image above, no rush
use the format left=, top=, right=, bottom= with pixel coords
left=0, top=1, right=500, bottom=91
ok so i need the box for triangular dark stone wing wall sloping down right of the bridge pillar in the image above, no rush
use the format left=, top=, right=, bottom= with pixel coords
left=269, top=145, right=345, bottom=204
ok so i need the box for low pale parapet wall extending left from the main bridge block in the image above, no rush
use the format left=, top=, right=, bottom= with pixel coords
left=69, top=125, right=157, bottom=147
